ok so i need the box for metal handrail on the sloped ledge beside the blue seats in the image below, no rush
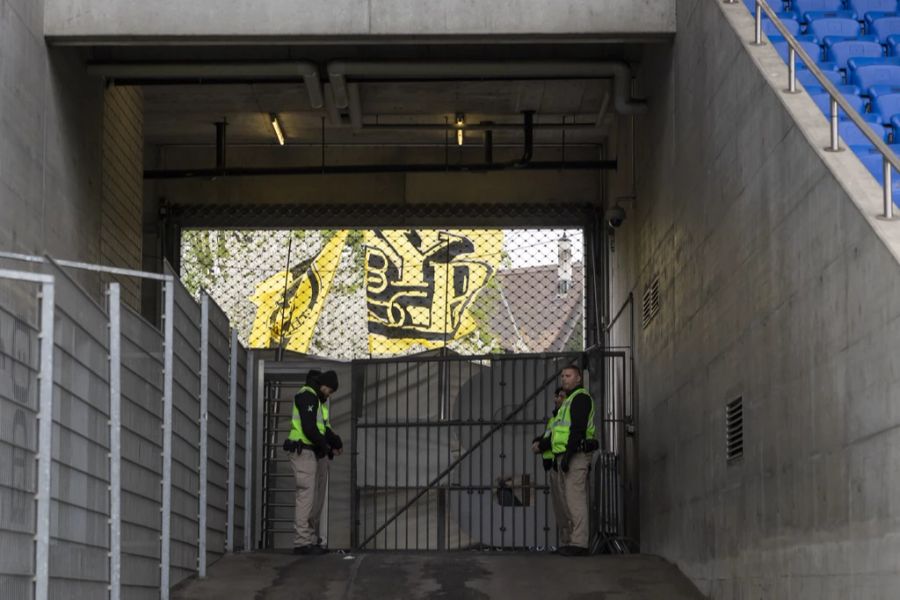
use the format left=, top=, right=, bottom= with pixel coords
left=725, top=0, right=900, bottom=219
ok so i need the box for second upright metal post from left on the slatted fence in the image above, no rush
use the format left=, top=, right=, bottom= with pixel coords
left=107, top=283, right=122, bottom=600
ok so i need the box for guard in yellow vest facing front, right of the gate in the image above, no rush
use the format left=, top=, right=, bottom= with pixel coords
left=550, top=366, right=599, bottom=556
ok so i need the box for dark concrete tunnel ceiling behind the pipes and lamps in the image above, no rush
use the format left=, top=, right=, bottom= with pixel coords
left=119, top=43, right=643, bottom=169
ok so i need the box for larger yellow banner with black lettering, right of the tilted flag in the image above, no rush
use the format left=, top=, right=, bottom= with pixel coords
left=365, top=229, right=503, bottom=355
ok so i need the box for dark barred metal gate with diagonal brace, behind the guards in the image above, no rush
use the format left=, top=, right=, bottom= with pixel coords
left=350, top=352, right=624, bottom=550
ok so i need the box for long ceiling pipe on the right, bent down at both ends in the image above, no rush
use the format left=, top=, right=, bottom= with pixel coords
left=327, top=60, right=647, bottom=115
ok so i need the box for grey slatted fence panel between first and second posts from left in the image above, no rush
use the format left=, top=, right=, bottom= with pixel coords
left=47, top=264, right=109, bottom=600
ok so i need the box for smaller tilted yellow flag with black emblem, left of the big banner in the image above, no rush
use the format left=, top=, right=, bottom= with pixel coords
left=249, top=230, right=349, bottom=354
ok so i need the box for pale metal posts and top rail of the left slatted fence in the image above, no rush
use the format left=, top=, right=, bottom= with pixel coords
left=0, top=251, right=254, bottom=600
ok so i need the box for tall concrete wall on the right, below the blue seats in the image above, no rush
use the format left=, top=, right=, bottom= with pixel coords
left=610, top=0, right=900, bottom=600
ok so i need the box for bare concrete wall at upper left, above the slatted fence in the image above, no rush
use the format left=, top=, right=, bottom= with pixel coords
left=0, top=0, right=103, bottom=262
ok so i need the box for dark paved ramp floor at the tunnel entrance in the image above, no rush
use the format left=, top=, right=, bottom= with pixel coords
left=172, top=552, right=703, bottom=600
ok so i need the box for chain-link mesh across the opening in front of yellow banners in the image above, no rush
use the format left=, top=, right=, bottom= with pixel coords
left=181, top=229, right=585, bottom=360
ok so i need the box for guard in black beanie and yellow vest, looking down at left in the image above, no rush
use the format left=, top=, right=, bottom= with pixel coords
left=284, top=370, right=343, bottom=554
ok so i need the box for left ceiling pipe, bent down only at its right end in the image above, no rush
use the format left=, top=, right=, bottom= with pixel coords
left=87, top=61, right=324, bottom=109
